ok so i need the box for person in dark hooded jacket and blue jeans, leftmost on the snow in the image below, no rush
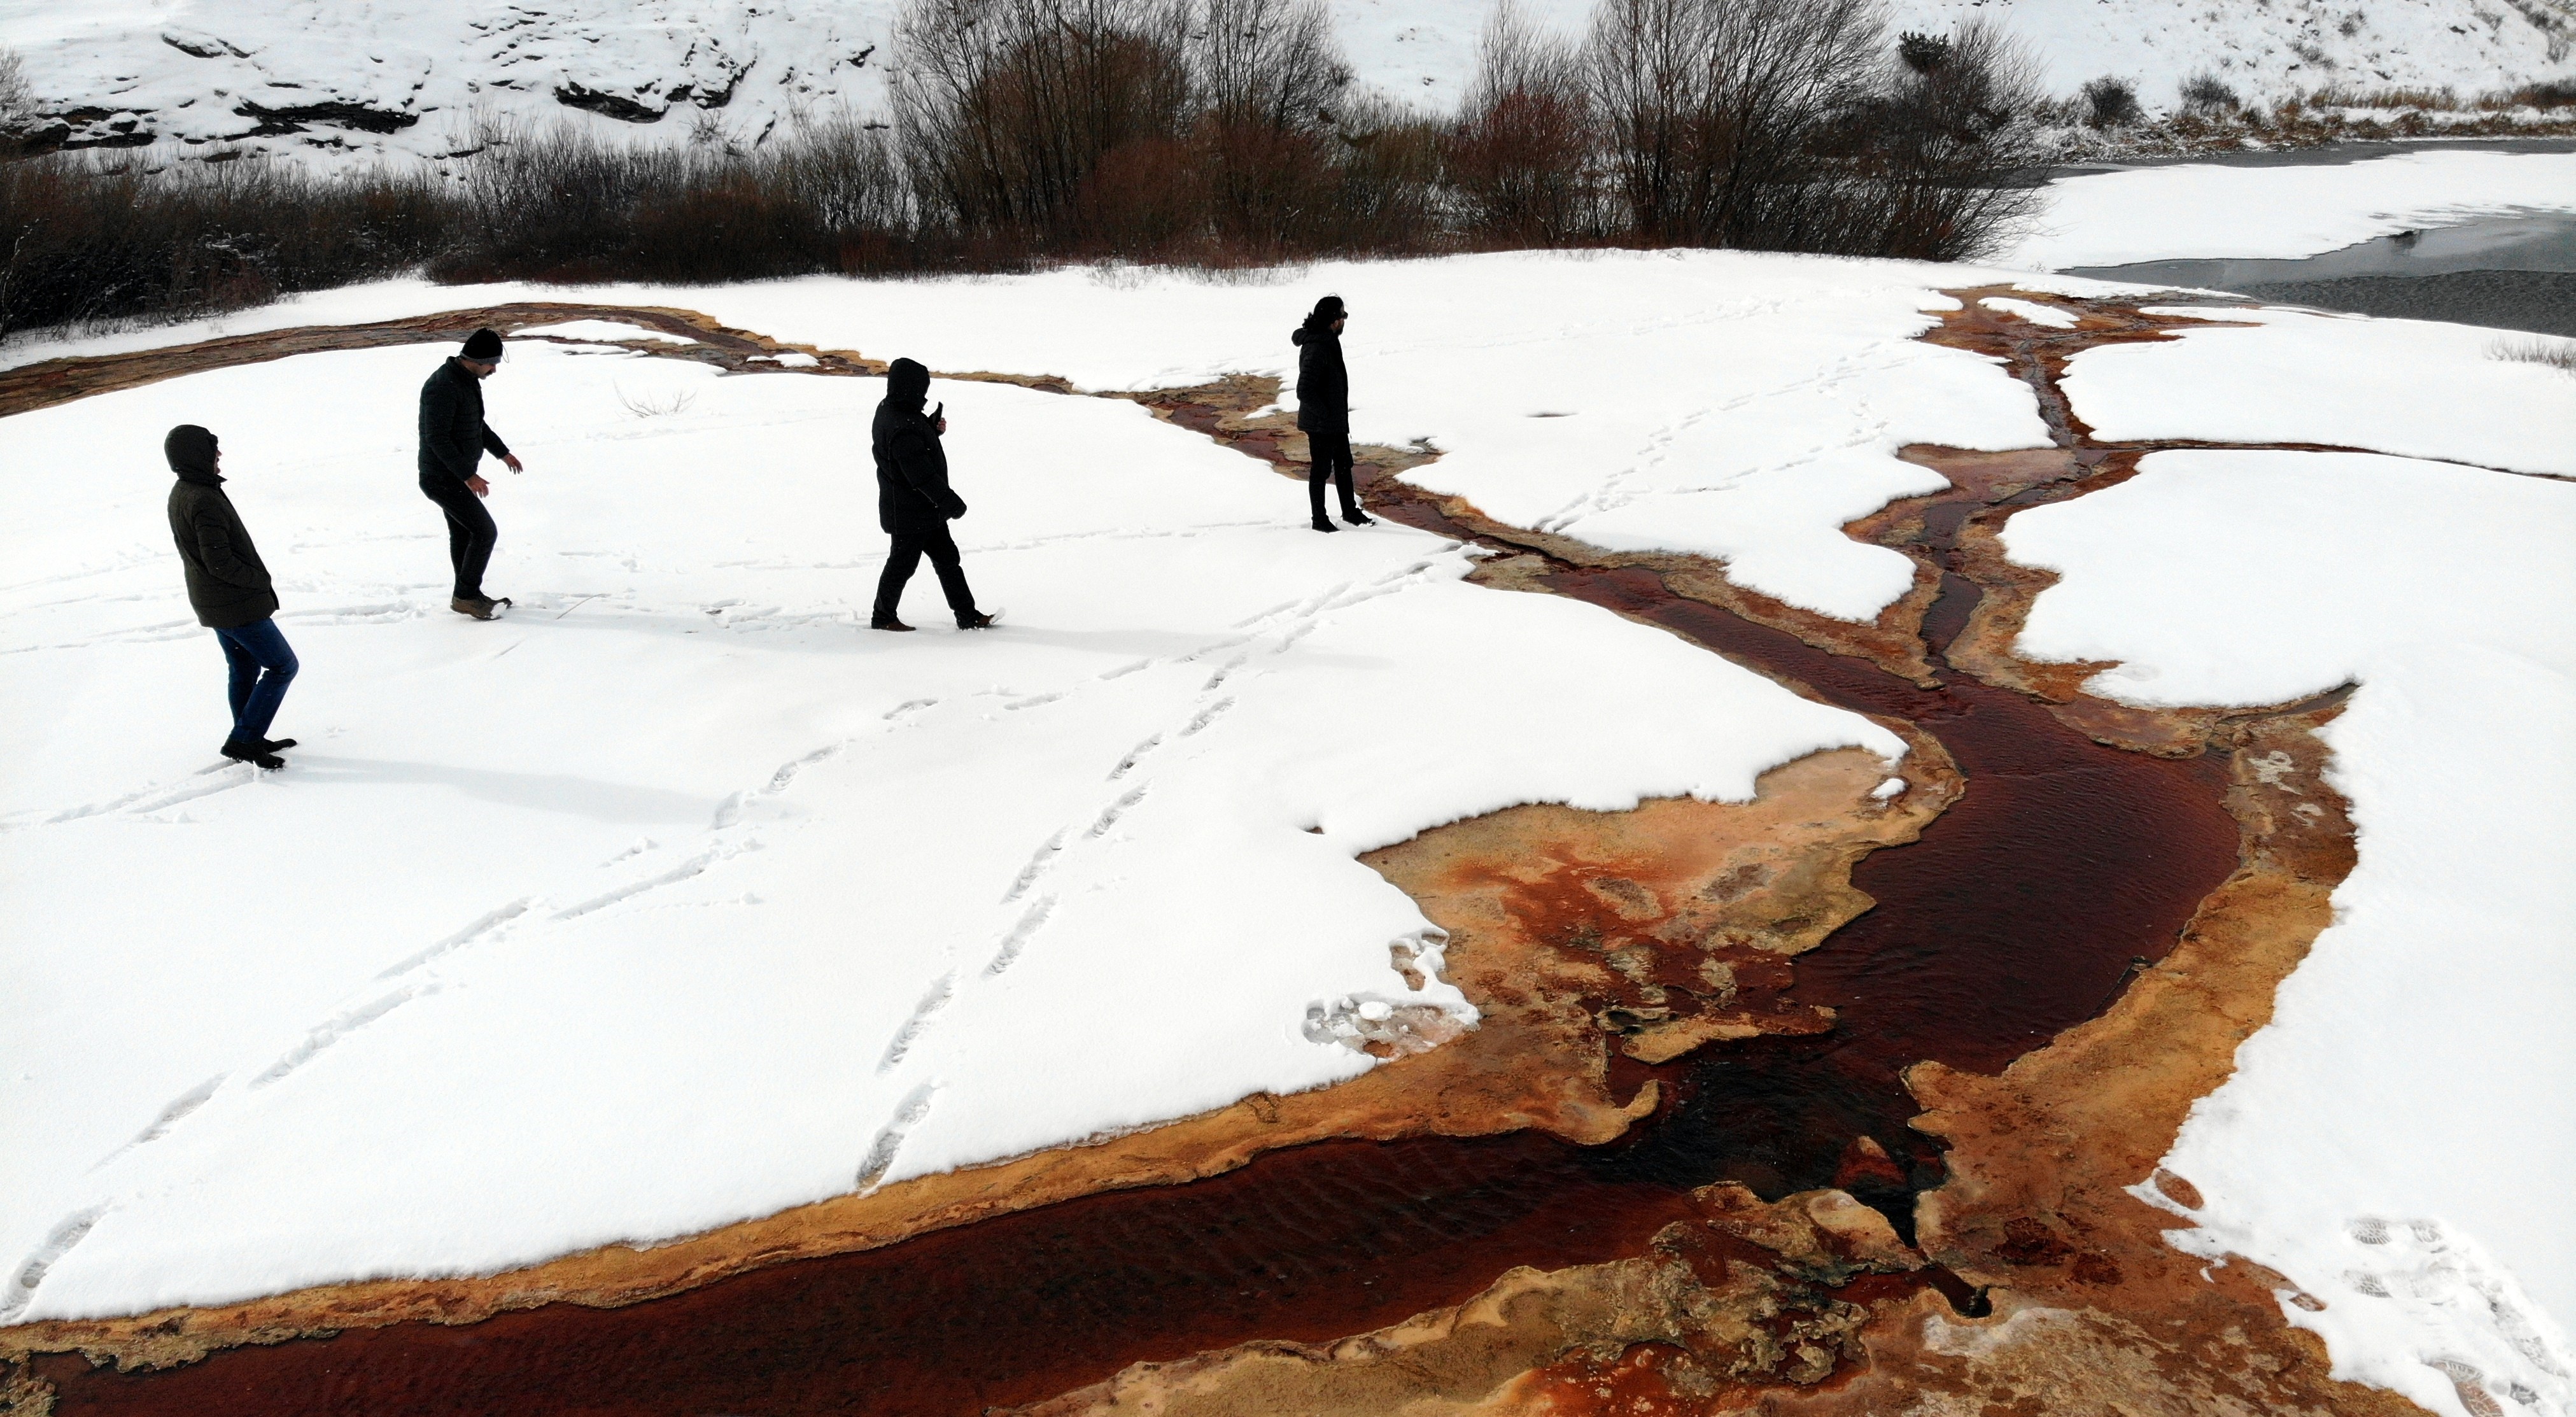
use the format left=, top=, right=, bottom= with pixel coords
left=162, top=423, right=296, bottom=770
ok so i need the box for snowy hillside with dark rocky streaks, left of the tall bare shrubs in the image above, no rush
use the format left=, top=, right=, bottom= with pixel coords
left=0, top=0, right=894, bottom=157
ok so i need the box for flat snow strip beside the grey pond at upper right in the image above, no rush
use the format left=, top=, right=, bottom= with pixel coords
left=1996, top=152, right=2576, bottom=271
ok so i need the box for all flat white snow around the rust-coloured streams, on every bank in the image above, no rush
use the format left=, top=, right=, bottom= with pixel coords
left=0, top=238, right=2576, bottom=1412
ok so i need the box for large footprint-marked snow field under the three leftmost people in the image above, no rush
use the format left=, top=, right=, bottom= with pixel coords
left=0, top=340, right=1901, bottom=1322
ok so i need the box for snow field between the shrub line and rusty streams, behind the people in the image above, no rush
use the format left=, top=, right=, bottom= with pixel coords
left=10, top=250, right=2081, bottom=621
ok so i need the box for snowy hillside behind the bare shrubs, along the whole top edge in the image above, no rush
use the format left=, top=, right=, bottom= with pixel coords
left=0, top=0, right=2576, bottom=157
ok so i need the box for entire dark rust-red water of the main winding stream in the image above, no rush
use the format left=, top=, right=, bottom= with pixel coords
left=41, top=456, right=2236, bottom=1417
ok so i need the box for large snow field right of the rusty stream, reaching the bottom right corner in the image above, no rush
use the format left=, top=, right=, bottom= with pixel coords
left=2004, top=451, right=2576, bottom=1414
